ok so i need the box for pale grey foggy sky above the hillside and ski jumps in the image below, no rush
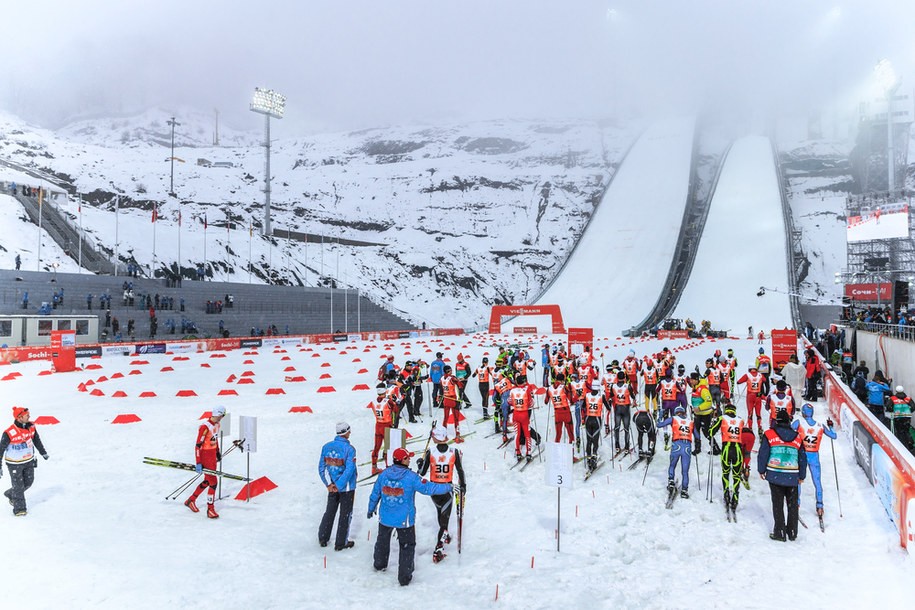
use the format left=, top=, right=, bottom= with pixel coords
left=0, top=0, right=915, bottom=135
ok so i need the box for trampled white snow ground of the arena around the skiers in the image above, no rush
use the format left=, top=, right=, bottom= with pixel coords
left=0, top=335, right=912, bottom=608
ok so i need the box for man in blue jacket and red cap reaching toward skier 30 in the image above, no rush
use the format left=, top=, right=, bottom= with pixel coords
left=368, top=447, right=451, bottom=586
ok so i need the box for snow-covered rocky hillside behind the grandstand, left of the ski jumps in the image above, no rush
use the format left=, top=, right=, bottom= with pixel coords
left=0, top=110, right=643, bottom=328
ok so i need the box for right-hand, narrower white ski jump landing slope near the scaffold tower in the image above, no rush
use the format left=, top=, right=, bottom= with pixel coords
left=674, top=136, right=792, bottom=336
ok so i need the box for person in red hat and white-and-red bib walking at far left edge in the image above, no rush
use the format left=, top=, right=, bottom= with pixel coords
left=0, top=407, right=48, bottom=517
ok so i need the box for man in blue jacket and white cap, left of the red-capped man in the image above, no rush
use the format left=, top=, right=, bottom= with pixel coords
left=318, top=422, right=356, bottom=551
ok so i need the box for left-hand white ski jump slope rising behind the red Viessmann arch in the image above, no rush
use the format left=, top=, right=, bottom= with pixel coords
left=535, top=118, right=695, bottom=336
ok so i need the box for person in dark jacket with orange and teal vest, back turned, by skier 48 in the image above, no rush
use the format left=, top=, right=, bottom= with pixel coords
left=756, top=409, right=807, bottom=542
